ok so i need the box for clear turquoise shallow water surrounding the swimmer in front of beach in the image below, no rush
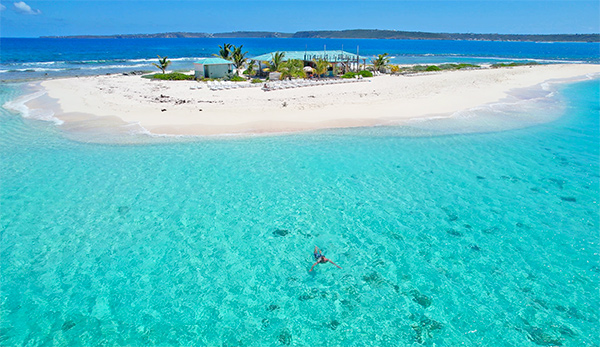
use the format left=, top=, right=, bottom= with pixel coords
left=0, top=80, right=600, bottom=346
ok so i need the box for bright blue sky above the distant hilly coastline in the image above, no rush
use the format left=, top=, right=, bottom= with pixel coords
left=0, top=0, right=600, bottom=37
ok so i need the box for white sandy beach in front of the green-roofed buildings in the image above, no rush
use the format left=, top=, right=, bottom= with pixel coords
left=41, top=64, right=600, bottom=135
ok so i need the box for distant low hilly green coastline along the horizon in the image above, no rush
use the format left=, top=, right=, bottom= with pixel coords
left=41, top=29, right=600, bottom=42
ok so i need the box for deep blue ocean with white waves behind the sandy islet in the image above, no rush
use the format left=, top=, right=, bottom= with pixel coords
left=0, top=38, right=600, bottom=80
